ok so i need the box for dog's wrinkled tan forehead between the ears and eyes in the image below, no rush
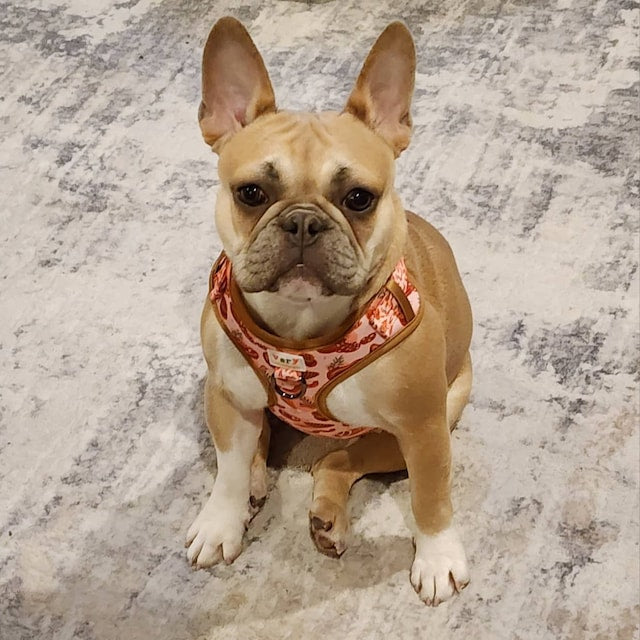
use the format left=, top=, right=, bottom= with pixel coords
left=218, top=112, right=394, bottom=193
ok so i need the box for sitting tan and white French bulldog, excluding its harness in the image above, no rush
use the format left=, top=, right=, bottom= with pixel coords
left=186, top=17, right=472, bottom=605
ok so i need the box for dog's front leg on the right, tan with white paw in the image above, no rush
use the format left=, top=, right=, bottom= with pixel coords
left=398, top=411, right=469, bottom=606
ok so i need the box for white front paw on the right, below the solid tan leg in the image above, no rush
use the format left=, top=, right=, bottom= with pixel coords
left=411, top=527, right=469, bottom=607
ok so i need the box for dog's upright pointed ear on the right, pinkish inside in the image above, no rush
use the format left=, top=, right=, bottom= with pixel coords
left=344, top=22, right=416, bottom=158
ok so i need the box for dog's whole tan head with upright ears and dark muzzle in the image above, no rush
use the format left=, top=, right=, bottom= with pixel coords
left=199, top=18, right=415, bottom=308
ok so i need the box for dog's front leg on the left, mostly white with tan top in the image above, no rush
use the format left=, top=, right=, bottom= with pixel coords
left=186, top=378, right=264, bottom=568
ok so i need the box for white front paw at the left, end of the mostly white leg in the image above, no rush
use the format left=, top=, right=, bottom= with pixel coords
left=185, top=498, right=249, bottom=569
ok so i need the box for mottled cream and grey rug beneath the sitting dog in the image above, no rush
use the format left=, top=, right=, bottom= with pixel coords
left=0, top=0, right=639, bottom=640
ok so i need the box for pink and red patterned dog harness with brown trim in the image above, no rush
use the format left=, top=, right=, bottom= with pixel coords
left=209, top=253, right=421, bottom=438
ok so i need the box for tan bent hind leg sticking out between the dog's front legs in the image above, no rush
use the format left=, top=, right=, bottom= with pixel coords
left=309, top=433, right=405, bottom=558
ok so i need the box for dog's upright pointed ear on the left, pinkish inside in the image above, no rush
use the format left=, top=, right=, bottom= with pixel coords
left=198, top=17, right=276, bottom=151
